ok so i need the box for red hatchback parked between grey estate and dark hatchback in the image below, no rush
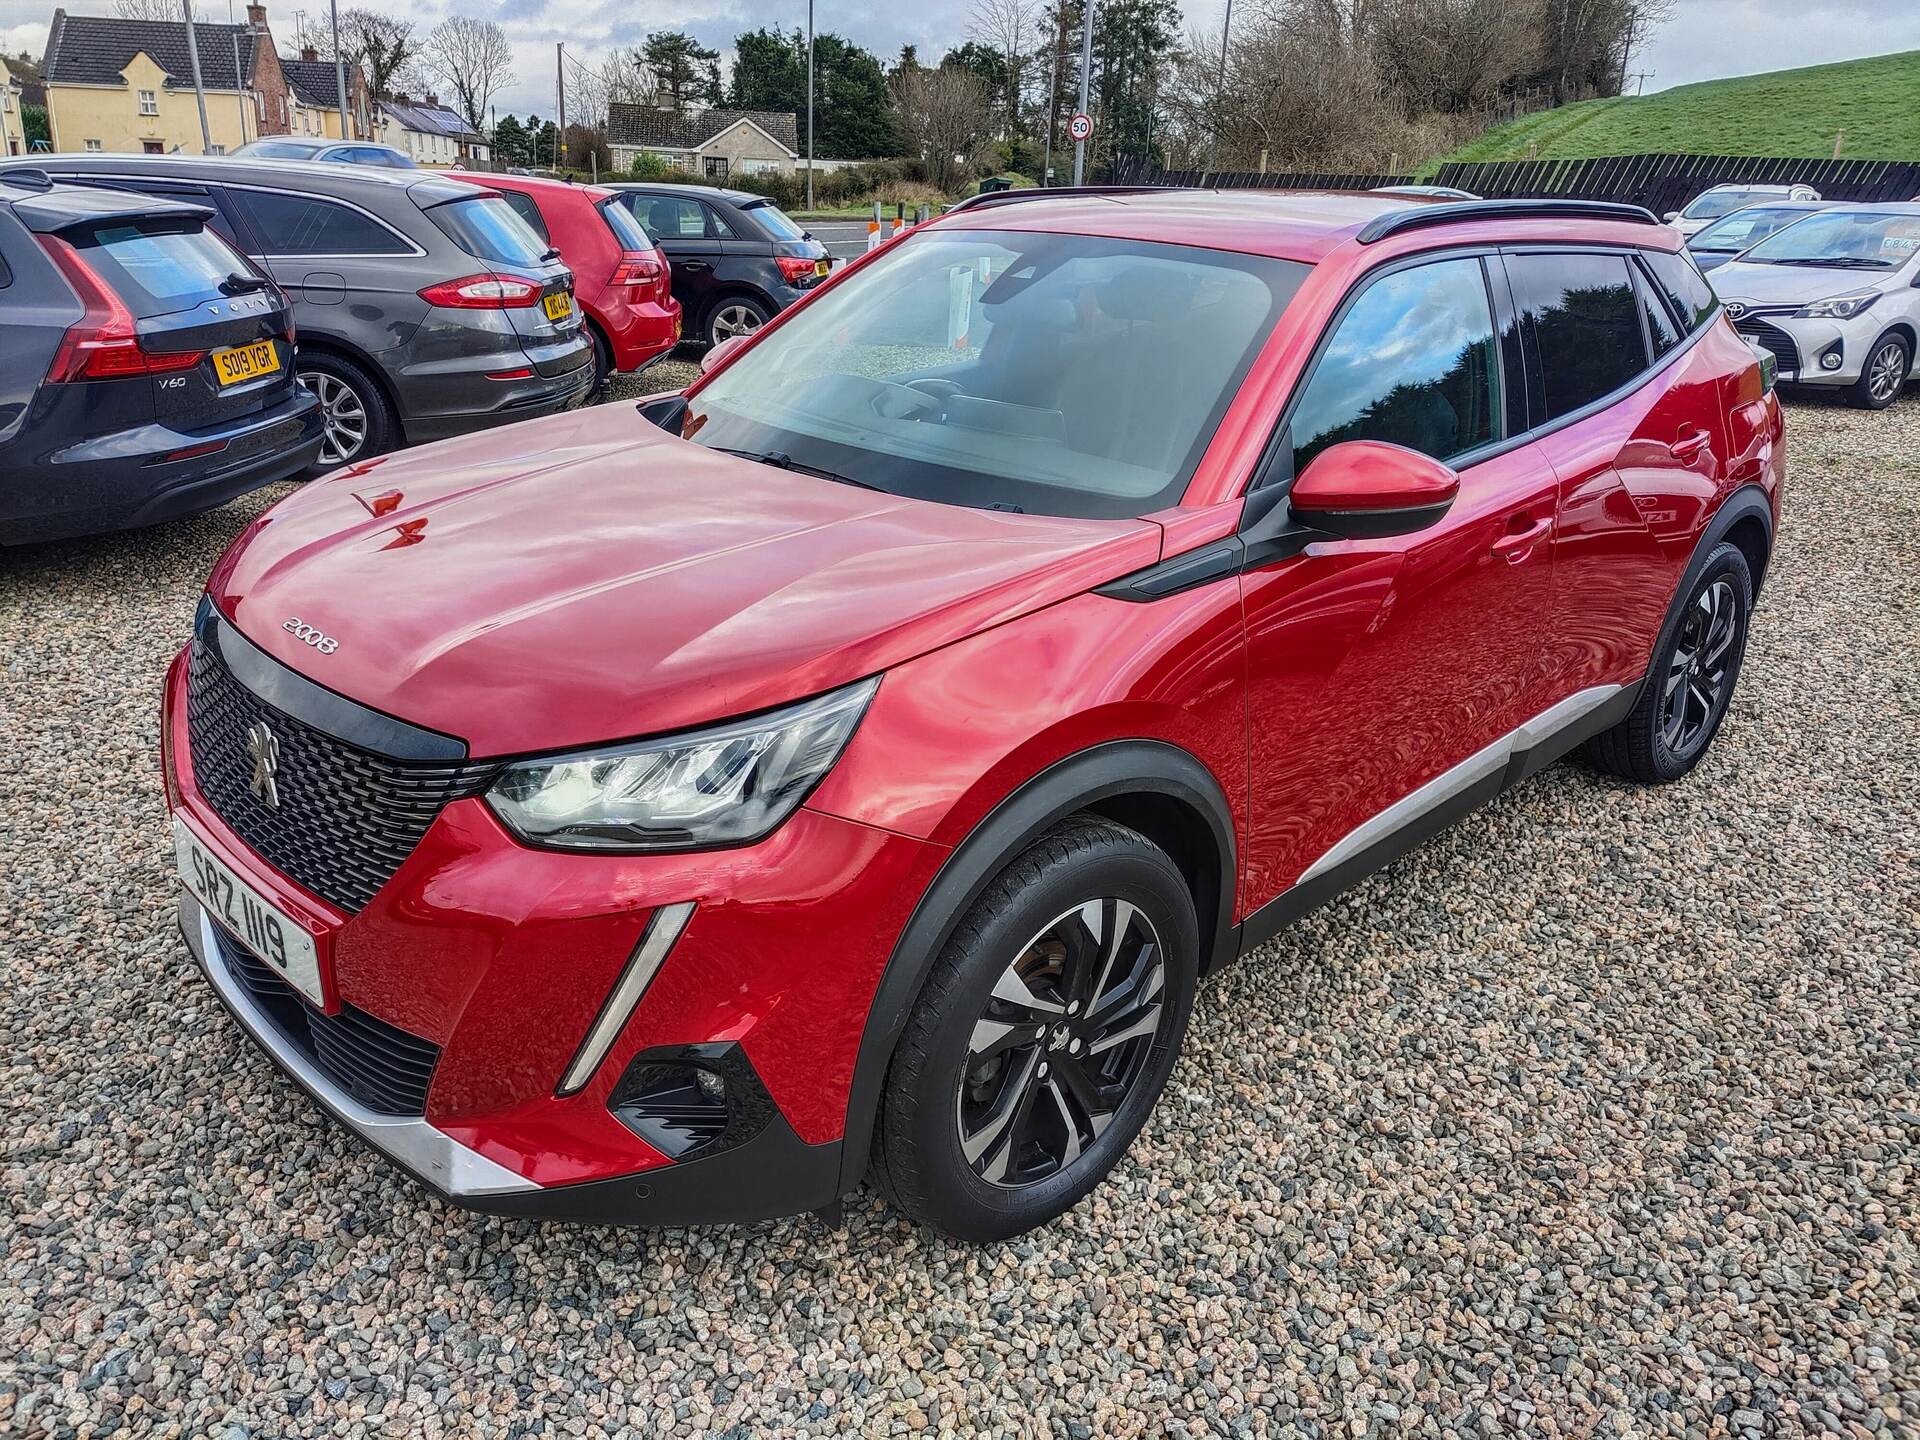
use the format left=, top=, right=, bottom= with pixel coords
left=455, top=171, right=680, bottom=394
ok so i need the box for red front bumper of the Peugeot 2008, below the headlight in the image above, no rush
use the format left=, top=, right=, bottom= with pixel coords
left=163, top=633, right=945, bottom=1225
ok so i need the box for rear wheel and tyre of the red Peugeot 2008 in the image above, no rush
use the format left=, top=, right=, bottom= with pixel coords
left=1588, top=541, right=1753, bottom=785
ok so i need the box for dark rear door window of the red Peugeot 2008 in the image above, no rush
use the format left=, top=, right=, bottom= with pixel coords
left=1507, top=253, right=1647, bottom=420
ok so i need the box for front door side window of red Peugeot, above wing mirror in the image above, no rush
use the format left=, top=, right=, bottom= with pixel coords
left=1292, top=257, right=1505, bottom=472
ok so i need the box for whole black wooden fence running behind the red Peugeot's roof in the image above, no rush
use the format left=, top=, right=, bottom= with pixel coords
left=1112, top=156, right=1920, bottom=215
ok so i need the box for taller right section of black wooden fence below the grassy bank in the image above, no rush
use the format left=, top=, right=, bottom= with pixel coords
left=1432, top=156, right=1920, bottom=215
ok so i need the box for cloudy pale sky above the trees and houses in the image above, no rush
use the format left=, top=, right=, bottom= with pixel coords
left=0, top=0, right=1920, bottom=115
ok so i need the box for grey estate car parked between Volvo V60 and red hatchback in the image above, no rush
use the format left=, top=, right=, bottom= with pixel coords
left=0, top=156, right=593, bottom=468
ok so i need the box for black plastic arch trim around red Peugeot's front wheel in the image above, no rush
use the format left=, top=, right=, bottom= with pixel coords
left=839, top=739, right=1238, bottom=1194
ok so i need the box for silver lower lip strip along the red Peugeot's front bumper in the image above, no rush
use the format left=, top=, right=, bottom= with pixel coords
left=180, top=895, right=541, bottom=1200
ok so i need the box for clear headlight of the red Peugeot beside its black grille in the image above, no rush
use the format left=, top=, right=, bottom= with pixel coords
left=486, top=678, right=879, bottom=851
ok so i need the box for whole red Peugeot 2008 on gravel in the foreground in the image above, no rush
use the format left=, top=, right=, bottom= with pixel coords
left=163, top=192, right=1784, bottom=1238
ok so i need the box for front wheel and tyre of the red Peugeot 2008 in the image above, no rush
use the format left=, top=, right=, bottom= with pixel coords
left=874, top=818, right=1200, bottom=1240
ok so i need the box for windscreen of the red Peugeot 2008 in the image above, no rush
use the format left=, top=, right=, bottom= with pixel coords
left=685, top=230, right=1308, bottom=516
